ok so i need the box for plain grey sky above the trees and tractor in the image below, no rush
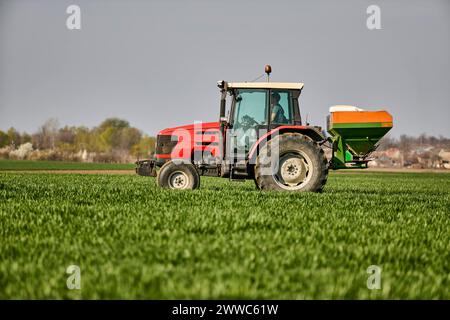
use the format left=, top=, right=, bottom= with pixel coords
left=0, top=0, right=450, bottom=136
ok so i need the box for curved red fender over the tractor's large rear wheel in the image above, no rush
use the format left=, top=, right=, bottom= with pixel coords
left=248, top=125, right=326, bottom=164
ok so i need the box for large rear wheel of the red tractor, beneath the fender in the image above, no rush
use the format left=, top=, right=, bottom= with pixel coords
left=255, top=132, right=328, bottom=192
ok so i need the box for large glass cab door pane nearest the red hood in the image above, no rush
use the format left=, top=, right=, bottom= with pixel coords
left=233, top=89, right=267, bottom=151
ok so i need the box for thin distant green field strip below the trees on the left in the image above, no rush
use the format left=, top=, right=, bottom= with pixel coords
left=0, top=159, right=135, bottom=171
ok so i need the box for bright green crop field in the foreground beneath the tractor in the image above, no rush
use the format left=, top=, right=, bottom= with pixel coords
left=0, top=173, right=450, bottom=299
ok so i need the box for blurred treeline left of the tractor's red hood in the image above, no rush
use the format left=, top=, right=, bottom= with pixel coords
left=0, top=118, right=155, bottom=162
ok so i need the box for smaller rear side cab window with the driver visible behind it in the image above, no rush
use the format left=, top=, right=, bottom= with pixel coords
left=270, top=90, right=294, bottom=125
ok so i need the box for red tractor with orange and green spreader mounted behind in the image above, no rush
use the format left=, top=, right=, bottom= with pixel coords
left=136, top=66, right=392, bottom=192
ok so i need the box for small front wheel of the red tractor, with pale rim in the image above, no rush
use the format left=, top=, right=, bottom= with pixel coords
left=156, top=160, right=200, bottom=190
